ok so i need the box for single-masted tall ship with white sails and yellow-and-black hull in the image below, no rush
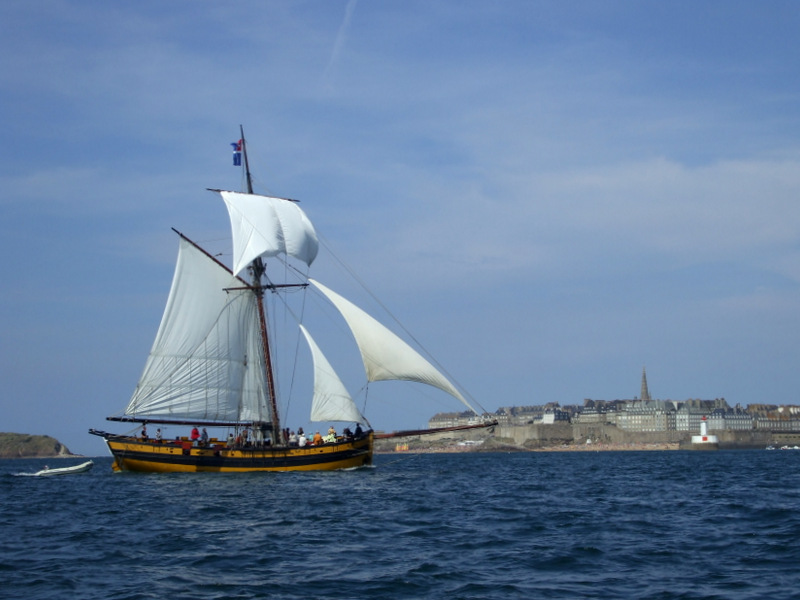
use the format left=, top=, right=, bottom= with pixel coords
left=89, top=127, right=494, bottom=472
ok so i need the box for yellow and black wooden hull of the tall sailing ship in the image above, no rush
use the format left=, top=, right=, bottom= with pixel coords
left=100, top=432, right=373, bottom=473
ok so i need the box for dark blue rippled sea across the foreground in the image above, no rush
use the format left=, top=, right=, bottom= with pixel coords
left=0, top=450, right=800, bottom=600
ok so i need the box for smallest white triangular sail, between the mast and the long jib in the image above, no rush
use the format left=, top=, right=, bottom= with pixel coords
left=300, top=325, right=366, bottom=423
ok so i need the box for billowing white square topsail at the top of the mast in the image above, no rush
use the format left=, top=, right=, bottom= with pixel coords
left=219, top=191, right=319, bottom=275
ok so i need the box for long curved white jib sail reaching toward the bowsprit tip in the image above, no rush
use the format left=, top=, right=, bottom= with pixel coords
left=308, top=279, right=477, bottom=414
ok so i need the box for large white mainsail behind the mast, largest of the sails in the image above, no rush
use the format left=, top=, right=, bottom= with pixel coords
left=125, top=238, right=270, bottom=422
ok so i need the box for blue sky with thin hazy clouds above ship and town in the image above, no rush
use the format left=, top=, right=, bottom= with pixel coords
left=0, top=0, right=800, bottom=454
